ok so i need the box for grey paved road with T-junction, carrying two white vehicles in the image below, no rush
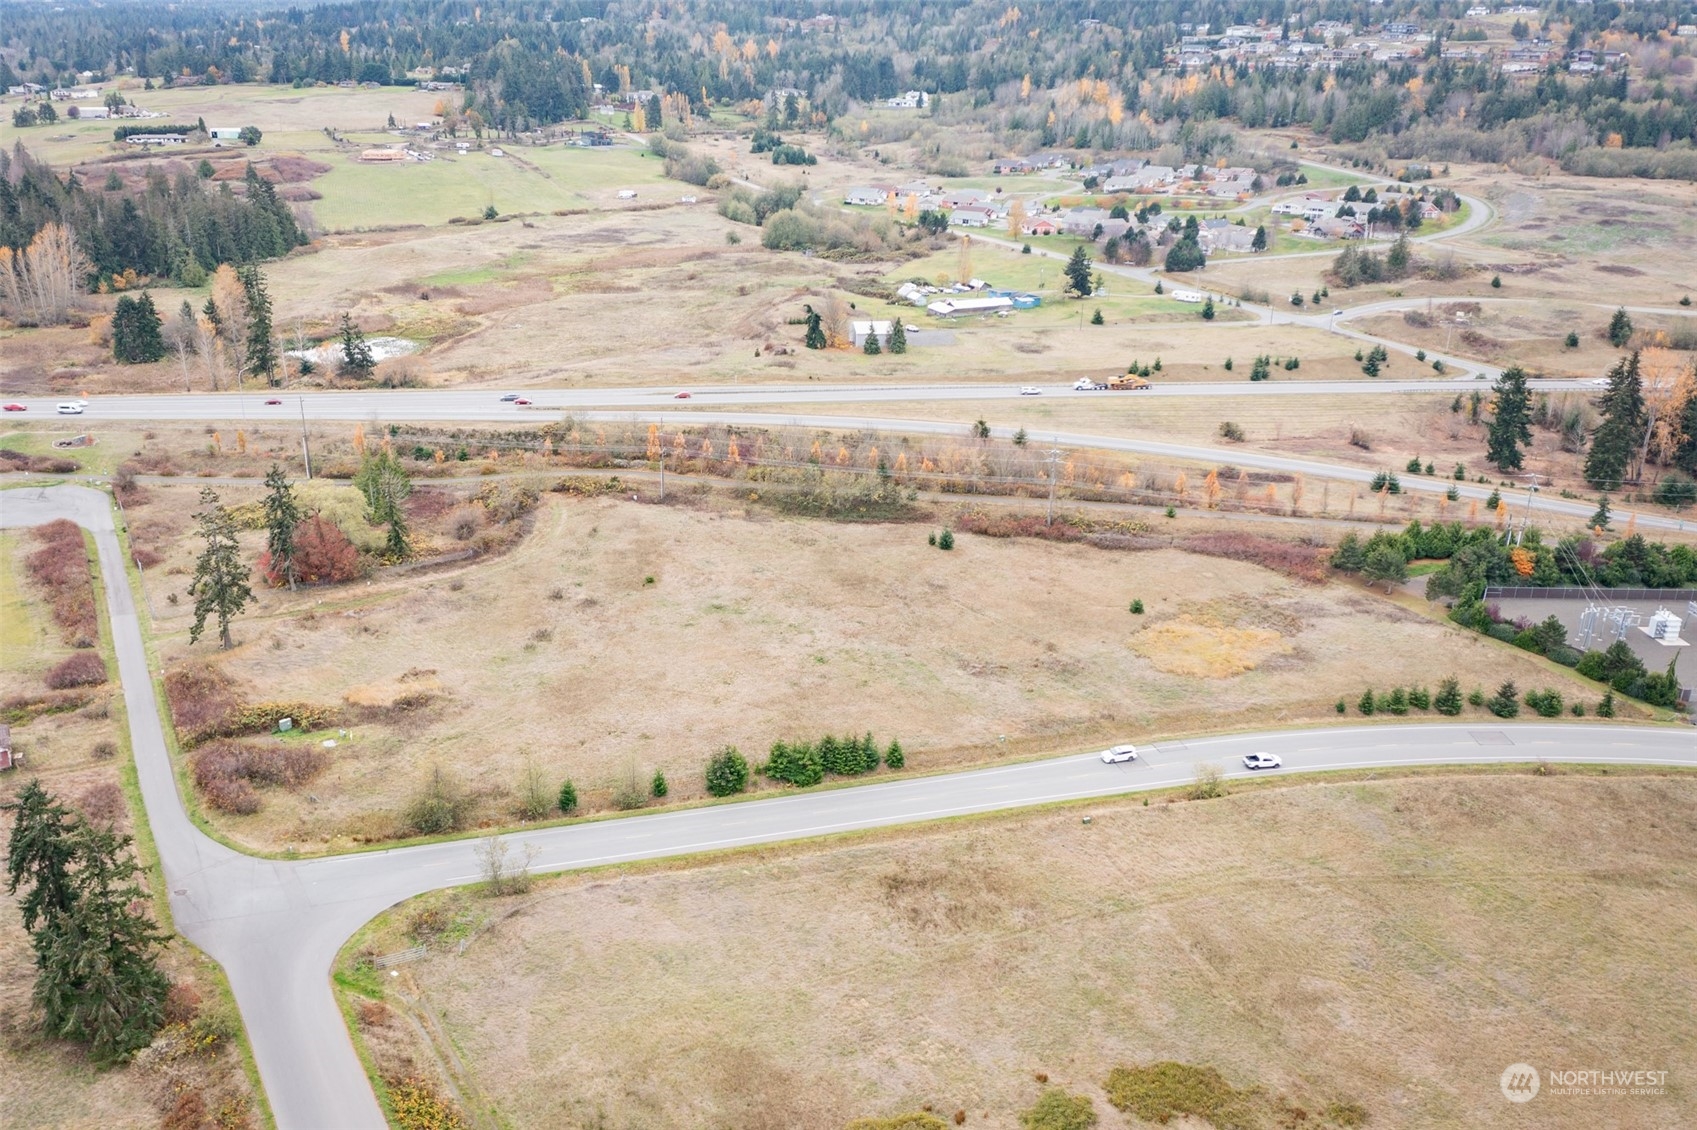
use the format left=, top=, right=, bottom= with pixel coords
left=0, top=487, right=1697, bottom=1130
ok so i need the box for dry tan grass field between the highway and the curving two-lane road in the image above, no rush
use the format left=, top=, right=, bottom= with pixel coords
left=132, top=487, right=1629, bottom=850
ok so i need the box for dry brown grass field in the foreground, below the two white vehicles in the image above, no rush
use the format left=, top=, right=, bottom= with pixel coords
left=351, top=774, right=1697, bottom=1130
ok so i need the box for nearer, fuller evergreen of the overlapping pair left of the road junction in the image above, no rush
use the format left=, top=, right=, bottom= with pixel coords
left=34, top=821, right=171, bottom=1064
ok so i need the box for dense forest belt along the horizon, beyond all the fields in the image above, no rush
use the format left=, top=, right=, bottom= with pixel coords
left=0, top=0, right=1697, bottom=165
